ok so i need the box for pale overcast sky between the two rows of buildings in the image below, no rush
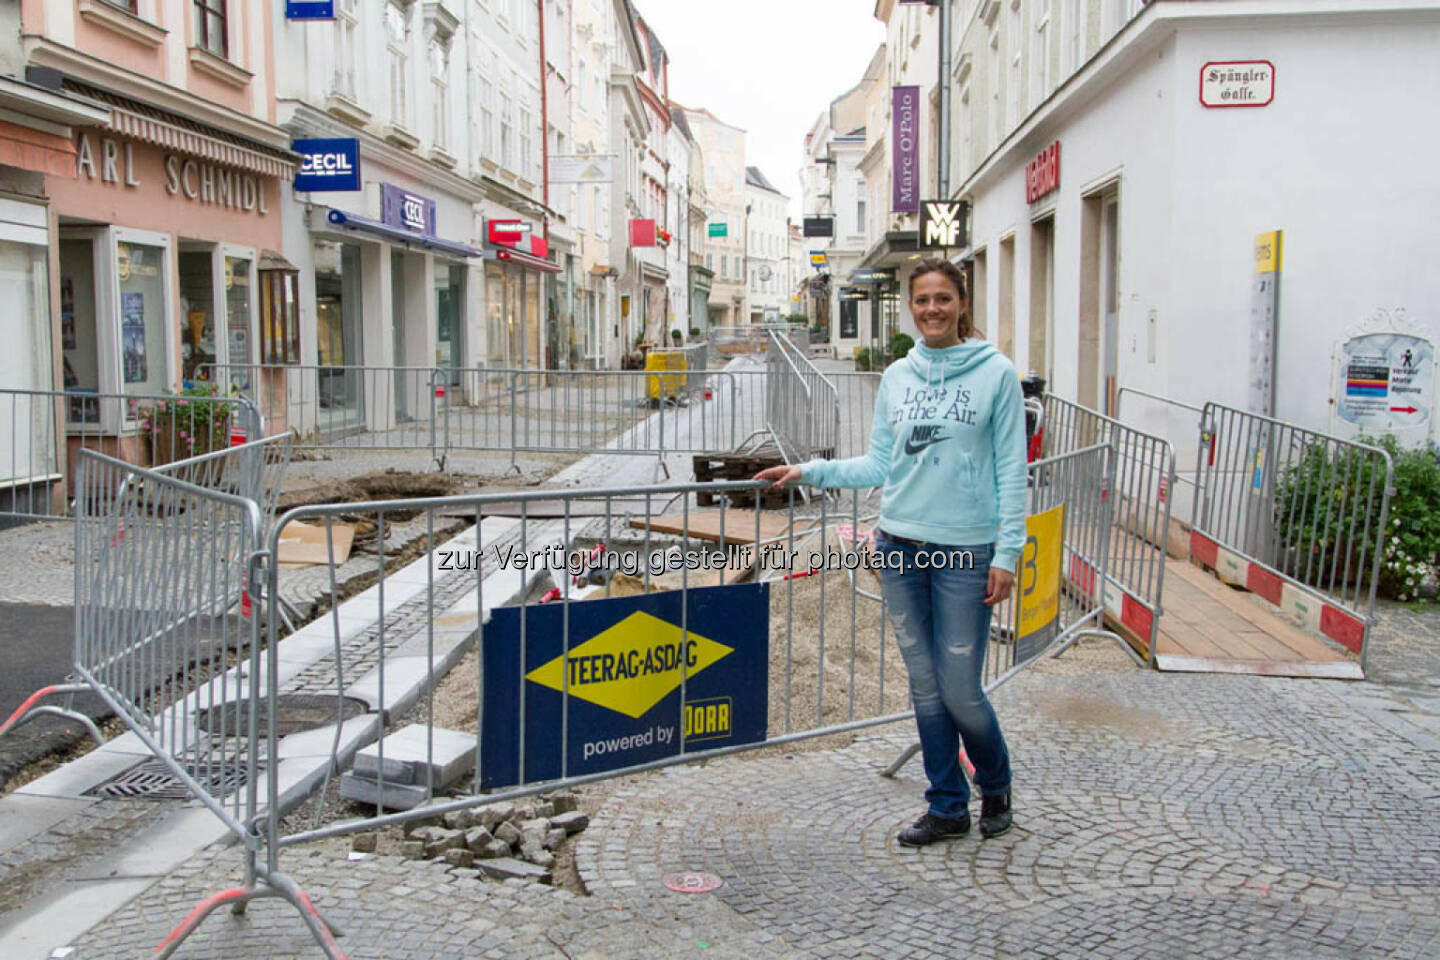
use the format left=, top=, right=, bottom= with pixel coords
left=635, top=0, right=886, bottom=219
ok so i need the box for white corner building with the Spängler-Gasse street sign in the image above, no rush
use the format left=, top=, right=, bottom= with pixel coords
left=955, top=0, right=1440, bottom=468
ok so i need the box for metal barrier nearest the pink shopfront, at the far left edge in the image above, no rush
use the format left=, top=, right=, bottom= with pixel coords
left=0, top=390, right=265, bottom=520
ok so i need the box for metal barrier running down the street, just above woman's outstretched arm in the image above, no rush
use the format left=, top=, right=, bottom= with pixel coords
left=765, top=334, right=840, bottom=463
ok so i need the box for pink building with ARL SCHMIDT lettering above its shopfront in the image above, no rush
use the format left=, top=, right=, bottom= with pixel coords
left=19, top=0, right=298, bottom=466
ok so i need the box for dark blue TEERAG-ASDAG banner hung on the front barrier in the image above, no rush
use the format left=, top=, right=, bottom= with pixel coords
left=480, top=583, right=770, bottom=790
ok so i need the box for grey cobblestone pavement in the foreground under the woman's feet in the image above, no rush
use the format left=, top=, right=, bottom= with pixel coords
left=64, top=640, right=1440, bottom=960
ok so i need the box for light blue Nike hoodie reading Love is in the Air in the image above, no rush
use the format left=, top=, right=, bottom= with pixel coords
left=801, top=340, right=1025, bottom=570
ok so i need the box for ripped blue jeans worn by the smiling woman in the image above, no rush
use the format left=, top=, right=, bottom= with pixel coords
left=876, top=531, right=1009, bottom=819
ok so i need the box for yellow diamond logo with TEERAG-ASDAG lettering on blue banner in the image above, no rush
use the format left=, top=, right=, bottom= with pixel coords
left=526, top=612, right=734, bottom=718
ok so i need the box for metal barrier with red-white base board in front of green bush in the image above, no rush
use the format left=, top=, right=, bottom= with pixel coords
left=1191, top=403, right=1394, bottom=668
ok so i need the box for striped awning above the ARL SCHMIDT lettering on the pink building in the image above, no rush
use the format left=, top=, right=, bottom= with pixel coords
left=65, top=81, right=298, bottom=180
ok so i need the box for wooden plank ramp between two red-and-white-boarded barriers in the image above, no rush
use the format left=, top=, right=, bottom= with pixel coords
left=1155, top=557, right=1365, bottom=679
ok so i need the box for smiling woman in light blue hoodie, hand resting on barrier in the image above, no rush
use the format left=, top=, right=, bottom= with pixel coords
left=756, top=258, right=1025, bottom=846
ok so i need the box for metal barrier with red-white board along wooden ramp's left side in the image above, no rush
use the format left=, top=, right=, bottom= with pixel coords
left=1041, top=393, right=1185, bottom=665
